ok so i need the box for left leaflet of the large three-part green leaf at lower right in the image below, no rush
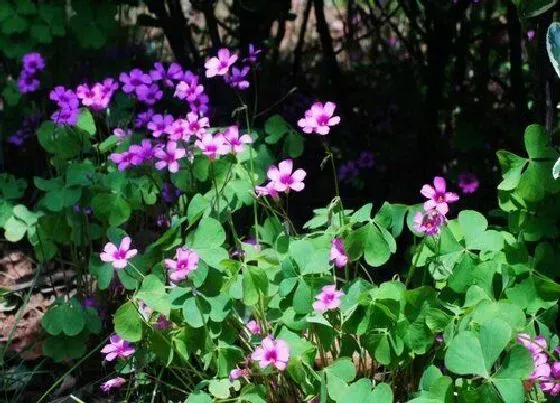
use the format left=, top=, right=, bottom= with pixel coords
left=445, top=331, right=490, bottom=378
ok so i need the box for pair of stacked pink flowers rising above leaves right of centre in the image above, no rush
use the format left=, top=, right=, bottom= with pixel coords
left=414, top=176, right=459, bottom=236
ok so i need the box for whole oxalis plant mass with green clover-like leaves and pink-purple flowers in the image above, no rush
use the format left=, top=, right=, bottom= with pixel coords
left=0, top=41, right=560, bottom=403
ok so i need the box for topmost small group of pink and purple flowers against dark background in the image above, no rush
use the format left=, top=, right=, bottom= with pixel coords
left=204, top=44, right=261, bottom=90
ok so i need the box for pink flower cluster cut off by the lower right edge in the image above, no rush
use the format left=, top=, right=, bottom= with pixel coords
left=517, top=333, right=560, bottom=396
